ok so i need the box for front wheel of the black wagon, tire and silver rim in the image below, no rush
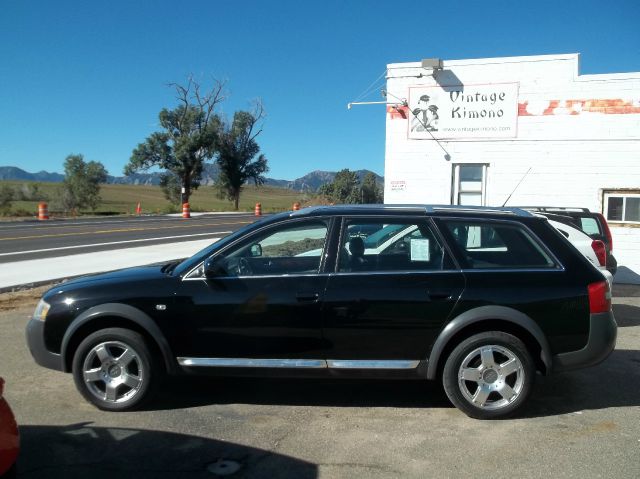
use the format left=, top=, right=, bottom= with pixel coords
left=72, top=328, right=162, bottom=411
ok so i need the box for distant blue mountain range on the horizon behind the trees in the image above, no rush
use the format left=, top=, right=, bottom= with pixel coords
left=0, top=164, right=384, bottom=192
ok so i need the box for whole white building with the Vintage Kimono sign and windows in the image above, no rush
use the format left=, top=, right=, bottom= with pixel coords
left=384, top=54, right=640, bottom=282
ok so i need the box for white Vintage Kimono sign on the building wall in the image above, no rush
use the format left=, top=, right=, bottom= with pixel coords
left=408, top=83, right=518, bottom=140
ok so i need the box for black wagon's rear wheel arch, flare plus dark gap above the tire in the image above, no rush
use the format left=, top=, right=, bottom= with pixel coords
left=427, top=306, right=553, bottom=379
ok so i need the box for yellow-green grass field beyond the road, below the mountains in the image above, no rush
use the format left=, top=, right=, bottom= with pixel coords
left=0, top=181, right=309, bottom=216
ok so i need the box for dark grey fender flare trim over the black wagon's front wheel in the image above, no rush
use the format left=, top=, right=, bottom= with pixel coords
left=60, top=303, right=177, bottom=374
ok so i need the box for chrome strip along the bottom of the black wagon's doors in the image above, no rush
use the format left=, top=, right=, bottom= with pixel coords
left=177, top=357, right=420, bottom=369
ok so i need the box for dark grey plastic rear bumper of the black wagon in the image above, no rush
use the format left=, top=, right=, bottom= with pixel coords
left=553, top=311, right=618, bottom=372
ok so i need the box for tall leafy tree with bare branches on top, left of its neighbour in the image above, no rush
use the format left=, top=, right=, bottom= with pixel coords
left=124, top=78, right=224, bottom=203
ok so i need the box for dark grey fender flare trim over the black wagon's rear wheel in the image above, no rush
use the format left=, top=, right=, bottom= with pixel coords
left=427, top=306, right=553, bottom=379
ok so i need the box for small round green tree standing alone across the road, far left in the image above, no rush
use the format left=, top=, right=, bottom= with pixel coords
left=61, top=155, right=107, bottom=211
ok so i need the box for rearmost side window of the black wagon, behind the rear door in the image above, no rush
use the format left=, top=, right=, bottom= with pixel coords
left=444, top=220, right=556, bottom=269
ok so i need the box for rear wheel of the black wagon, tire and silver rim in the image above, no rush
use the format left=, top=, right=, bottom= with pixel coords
left=442, top=331, right=535, bottom=419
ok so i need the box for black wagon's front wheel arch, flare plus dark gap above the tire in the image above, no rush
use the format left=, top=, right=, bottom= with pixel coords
left=60, top=303, right=178, bottom=374
